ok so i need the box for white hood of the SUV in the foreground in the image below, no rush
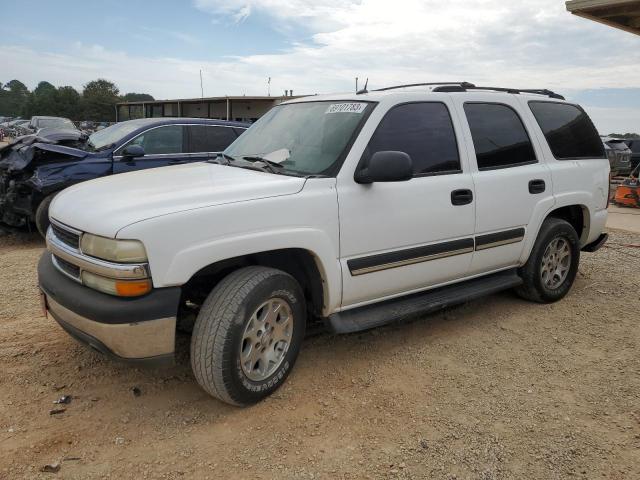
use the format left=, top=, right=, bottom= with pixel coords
left=49, top=163, right=305, bottom=237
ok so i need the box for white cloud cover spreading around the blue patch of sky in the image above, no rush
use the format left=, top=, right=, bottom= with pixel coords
left=0, top=0, right=640, bottom=131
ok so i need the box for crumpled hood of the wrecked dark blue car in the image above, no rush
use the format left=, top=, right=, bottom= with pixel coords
left=0, top=130, right=88, bottom=172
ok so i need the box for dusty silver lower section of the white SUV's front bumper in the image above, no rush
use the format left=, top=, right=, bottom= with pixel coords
left=47, top=295, right=176, bottom=359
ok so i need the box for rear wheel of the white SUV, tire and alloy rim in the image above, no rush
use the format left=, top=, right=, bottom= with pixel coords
left=516, top=217, right=580, bottom=303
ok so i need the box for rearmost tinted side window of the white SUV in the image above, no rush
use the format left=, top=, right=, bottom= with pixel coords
left=529, top=102, right=604, bottom=160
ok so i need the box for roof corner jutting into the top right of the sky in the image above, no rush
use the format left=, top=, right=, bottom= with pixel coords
left=567, top=0, right=640, bottom=35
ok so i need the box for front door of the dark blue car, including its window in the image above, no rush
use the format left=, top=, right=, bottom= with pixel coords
left=113, top=124, right=187, bottom=173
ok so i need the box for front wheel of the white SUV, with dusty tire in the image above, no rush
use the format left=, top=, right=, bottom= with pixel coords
left=191, top=266, right=306, bottom=406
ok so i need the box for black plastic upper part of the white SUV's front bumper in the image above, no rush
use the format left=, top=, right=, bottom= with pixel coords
left=38, top=251, right=181, bottom=324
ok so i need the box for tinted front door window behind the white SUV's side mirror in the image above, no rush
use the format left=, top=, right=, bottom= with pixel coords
left=363, top=102, right=460, bottom=176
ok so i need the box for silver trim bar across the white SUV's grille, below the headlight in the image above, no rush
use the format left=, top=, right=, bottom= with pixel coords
left=46, top=229, right=150, bottom=280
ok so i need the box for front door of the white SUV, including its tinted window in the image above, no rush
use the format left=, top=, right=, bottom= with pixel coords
left=338, top=102, right=475, bottom=307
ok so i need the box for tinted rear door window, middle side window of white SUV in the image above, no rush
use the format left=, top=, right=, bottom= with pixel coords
left=464, top=103, right=536, bottom=170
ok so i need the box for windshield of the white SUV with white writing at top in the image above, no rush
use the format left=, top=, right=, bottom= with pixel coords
left=224, top=102, right=373, bottom=175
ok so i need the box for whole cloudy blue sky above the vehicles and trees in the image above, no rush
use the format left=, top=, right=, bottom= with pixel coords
left=0, top=0, right=640, bottom=134
